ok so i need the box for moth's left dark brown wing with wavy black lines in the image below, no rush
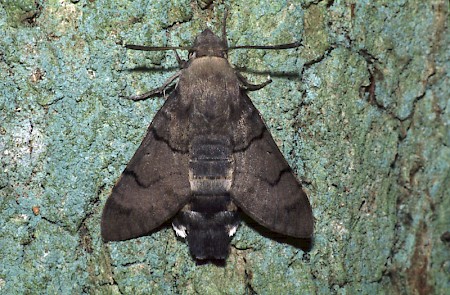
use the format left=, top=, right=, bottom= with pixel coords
left=101, top=94, right=190, bottom=241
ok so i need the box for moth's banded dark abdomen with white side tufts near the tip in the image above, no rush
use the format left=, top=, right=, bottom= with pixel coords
left=173, top=136, right=239, bottom=259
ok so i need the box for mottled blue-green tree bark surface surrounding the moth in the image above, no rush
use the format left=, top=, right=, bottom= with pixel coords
left=0, top=0, right=450, bottom=294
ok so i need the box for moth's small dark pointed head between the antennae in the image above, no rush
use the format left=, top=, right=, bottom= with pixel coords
left=189, top=29, right=228, bottom=58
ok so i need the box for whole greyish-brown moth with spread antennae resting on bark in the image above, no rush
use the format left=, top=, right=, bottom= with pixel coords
left=101, top=17, right=313, bottom=260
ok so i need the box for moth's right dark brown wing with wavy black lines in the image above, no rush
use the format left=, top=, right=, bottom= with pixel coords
left=230, top=93, right=314, bottom=238
